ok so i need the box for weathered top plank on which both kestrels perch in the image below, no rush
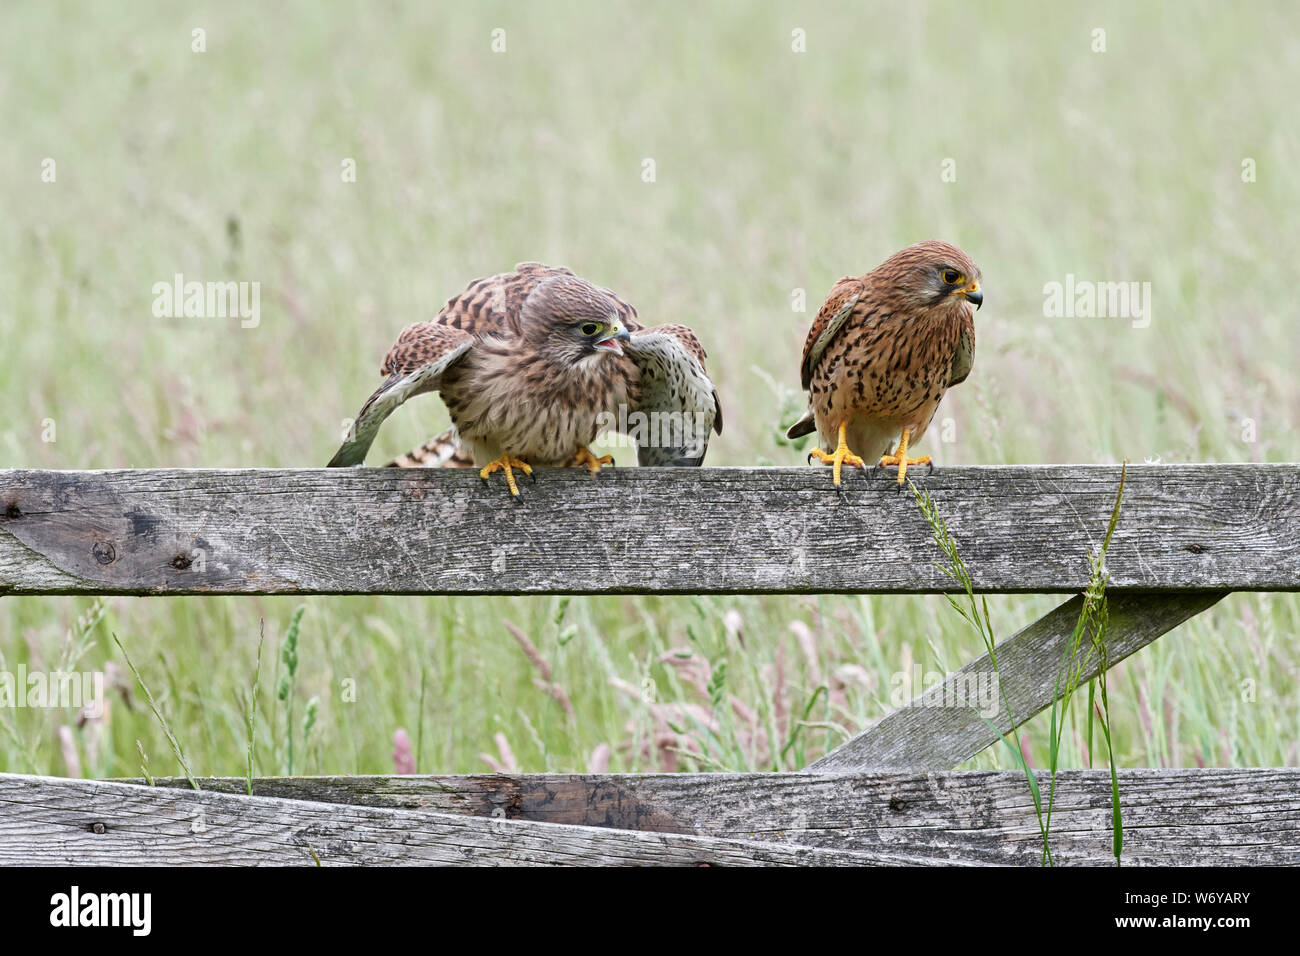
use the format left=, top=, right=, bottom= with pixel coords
left=0, top=464, right=1300, bottom=594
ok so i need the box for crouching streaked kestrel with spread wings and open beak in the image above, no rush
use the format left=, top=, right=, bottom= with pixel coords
left=329, top=263, right=723, bottom=496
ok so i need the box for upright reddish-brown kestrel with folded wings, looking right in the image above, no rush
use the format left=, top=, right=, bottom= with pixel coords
left=787, top=241, right=984, bottom=485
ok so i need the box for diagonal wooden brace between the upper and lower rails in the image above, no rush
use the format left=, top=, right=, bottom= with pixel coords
left=809, top=592, right=1223, bottom=773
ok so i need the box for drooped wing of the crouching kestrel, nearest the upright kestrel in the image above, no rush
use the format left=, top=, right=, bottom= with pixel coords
left=620, top=325, right=723, bottom=467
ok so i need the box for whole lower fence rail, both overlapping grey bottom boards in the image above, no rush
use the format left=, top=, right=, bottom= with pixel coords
left=0, top=767, right=1300, bottom=866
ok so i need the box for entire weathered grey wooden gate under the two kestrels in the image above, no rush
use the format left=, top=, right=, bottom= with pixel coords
left=0, top=464, right=1300, bottom=865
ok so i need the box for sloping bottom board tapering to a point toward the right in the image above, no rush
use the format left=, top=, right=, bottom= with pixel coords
left=0, top=774, right=913, bottom=866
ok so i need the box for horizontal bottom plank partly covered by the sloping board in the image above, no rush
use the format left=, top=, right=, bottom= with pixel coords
left=134, top=767, right=1300, bottom=866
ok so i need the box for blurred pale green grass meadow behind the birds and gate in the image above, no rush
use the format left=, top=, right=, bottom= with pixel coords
left=0, top=1, right=1300, bottom=775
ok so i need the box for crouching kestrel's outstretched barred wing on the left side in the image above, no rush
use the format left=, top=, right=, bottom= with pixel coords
left=326, top=323, right=475, bottom=468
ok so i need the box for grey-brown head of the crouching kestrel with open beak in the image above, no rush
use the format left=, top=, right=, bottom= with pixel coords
left=521, top=276, right=631, bottom=368
